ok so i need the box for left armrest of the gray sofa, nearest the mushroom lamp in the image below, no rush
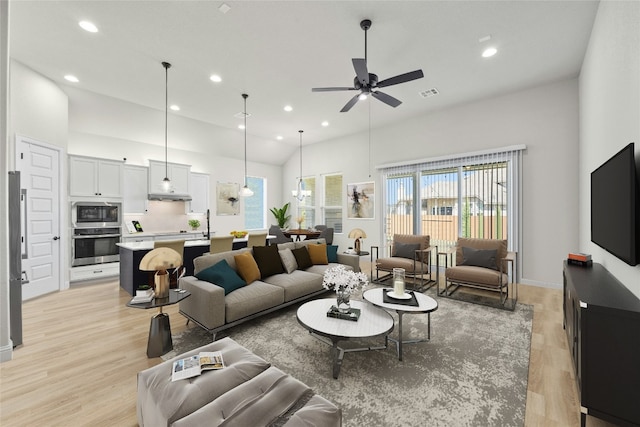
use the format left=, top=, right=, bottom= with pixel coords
left=180, top=276, right=225, bottom=329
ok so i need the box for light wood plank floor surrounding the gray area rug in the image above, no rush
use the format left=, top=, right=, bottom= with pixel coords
left=0, top=270, right=606, bottom=426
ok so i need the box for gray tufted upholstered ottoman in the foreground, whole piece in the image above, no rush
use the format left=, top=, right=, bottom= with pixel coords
left=137, top=338, right=342, bottom=427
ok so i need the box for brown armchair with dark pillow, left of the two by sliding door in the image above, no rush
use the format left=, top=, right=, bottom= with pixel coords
left=371, top=234, right=438, bottom=292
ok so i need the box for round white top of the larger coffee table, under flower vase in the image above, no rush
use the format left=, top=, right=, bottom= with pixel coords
left=297, top=298, right=393, bottom=338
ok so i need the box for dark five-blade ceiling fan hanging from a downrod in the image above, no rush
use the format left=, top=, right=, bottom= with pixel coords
left=311, top=19, right=424, bottom=113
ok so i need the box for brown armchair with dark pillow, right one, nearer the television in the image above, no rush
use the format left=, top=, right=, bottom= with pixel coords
left=438, top=237, right=518, bottom=310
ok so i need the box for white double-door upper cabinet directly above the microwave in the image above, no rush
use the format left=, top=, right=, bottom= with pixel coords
left=69, top=156, right=124, bottom=198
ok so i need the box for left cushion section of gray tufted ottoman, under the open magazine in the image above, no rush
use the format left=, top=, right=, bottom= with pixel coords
left=137, top=338, right=270, bottom=427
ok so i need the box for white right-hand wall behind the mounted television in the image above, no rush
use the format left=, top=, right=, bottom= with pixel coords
left=579, top=1, right=640, bottom=297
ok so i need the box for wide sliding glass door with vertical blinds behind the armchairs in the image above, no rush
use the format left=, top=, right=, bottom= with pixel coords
left=382, top=146, right=524, bottom=254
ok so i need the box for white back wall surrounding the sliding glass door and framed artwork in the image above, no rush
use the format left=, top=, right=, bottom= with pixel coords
left=283, top=78, right=578, bottom=287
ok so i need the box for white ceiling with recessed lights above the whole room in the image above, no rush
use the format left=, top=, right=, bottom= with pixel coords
left=10, top=0, right=598, bottom=164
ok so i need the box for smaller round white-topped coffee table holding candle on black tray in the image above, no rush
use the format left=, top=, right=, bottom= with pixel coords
left=362, top=288, right=438, bottom=360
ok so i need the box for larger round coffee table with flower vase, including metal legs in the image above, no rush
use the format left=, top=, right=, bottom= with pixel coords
left=296, top=298, right=393, bottom=379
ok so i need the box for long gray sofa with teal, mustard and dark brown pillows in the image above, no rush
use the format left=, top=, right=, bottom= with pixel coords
left=179, top=239, right=360, bottom=340
